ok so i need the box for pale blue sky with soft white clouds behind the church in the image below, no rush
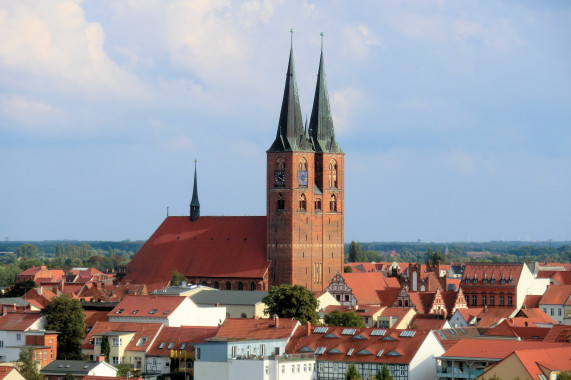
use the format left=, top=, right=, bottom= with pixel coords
left=0, top=0, right=571, bottom=242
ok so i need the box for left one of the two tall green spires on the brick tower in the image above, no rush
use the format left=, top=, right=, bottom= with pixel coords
left=268, top=29, right=312, bottom=152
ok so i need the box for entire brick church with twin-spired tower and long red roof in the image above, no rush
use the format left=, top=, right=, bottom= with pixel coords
left=120, top=38, right=345, bottom=292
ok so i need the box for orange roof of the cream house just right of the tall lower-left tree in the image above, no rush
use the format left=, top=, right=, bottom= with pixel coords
left=81, top=320, right=162, bottom=351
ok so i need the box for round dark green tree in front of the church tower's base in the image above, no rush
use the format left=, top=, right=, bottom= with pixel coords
left=262, top=284, right=319, bottom=324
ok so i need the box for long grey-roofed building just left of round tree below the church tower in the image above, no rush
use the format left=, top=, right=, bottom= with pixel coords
left=189, top=290, right=268, bottom=318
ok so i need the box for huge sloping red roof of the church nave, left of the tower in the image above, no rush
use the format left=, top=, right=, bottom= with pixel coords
left=125, top=216, right=269, bottom=291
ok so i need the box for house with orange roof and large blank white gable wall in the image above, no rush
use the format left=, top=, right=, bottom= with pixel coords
left=107, top=296, right=226, bottom=327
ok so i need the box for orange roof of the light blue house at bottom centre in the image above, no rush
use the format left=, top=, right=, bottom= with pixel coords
left=212, top=318, right=299, bottom=340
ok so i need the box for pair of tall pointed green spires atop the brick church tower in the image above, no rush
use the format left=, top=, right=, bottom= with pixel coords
left=268, top=30, right=342, bottom=153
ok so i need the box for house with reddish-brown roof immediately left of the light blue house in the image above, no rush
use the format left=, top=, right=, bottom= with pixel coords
left=145, top=327, right=219, bottom=375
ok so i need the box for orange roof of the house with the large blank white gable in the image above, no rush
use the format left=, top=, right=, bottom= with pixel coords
left=111, top=296, right=192, bottom=318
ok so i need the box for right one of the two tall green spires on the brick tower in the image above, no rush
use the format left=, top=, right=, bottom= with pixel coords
left=309, top=33, right=342, bottom=153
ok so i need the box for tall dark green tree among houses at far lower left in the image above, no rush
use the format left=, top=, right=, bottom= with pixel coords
left=43, top=294, right=85, bottom=360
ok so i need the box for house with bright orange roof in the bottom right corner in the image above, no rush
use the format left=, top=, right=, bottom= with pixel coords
left=479, top=346, right=571, bottom=380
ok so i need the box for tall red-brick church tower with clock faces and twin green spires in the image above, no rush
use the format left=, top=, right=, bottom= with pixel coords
left=266, top=35, right=344, bottom=291
